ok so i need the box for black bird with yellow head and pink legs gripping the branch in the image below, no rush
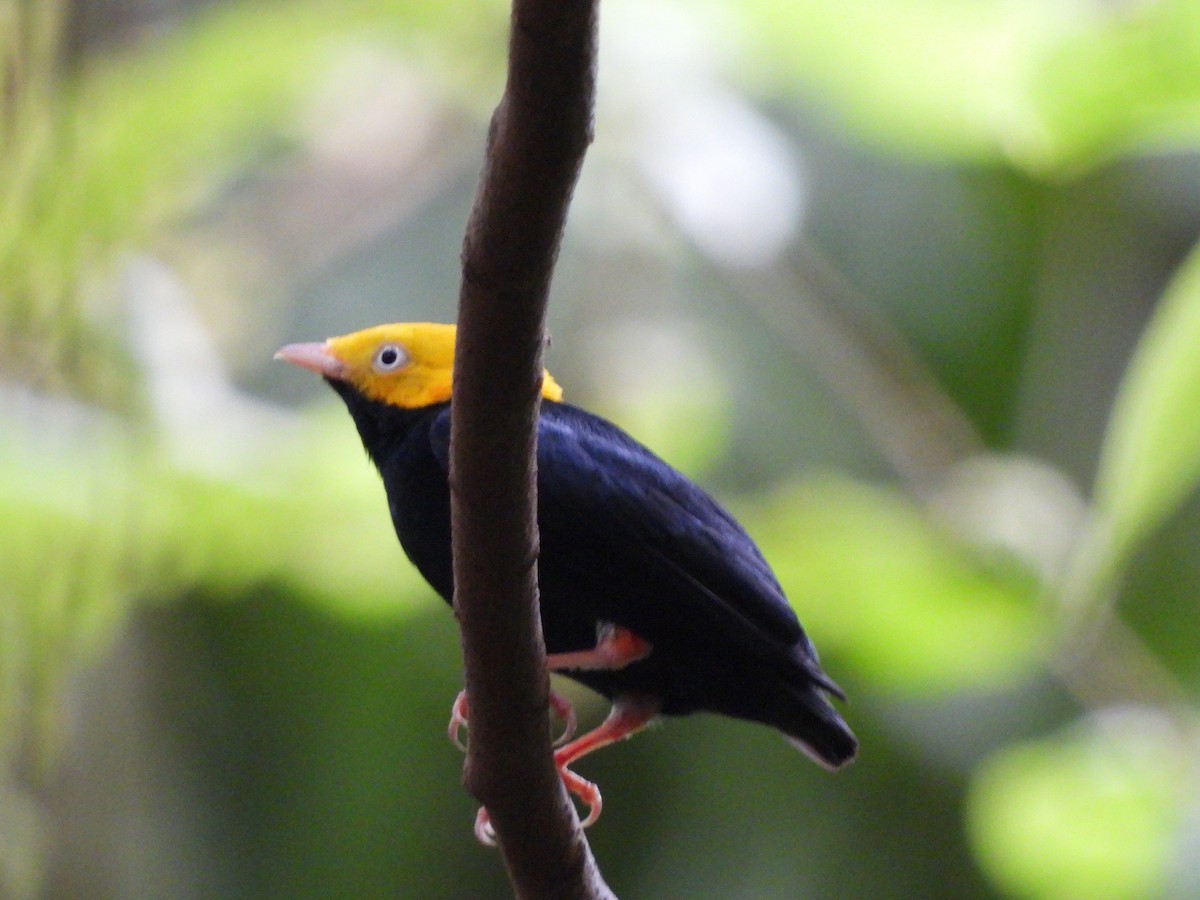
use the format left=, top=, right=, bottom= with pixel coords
left=276, top=323, right=858, bottom=844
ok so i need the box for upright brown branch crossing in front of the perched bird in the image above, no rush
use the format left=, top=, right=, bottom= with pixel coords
left=450, top=0, right=612, bottom=898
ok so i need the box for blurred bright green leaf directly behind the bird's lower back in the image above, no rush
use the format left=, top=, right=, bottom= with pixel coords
left=745, top=478, right=1048, bottom=692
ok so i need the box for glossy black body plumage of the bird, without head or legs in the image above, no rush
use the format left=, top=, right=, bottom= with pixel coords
left=330, top=379, right=857, bottom=767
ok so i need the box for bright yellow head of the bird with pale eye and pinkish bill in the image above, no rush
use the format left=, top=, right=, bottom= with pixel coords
left=275, top=322, right=563, bottom=409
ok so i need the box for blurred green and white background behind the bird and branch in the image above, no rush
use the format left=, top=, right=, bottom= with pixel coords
left=7, top=0, right=1200, bottom=900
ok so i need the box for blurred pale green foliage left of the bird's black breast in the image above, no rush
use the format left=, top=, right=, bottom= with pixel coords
left=0, top=396, right=429, bottom=766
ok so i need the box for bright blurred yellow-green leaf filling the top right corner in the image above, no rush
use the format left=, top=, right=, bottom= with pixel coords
left=745, top=0, right=1200, bottom=173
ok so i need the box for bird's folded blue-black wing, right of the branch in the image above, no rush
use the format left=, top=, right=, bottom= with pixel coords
left=431, top=403, right=814, bottom=656
